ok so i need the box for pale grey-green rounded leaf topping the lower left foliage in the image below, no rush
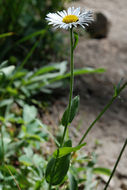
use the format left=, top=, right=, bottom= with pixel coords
left=23, top=104, right=37, bottom=123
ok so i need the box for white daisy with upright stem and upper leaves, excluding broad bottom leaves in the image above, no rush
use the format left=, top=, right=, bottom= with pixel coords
left=46, top=7, right=93, bottom=147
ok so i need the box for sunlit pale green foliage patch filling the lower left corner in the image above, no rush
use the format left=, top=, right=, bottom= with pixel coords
left=0, top=105, right=48, bottom=190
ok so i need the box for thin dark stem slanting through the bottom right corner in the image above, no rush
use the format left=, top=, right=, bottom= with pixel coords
left=104, top=139, right=127, bottom=190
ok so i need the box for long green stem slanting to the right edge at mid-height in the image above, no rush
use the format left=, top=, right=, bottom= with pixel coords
left=78, top=82, right=127, bottom=145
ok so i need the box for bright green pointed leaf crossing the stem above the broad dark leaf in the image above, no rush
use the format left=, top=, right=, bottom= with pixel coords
left=53, top=143, right=86, bottom=158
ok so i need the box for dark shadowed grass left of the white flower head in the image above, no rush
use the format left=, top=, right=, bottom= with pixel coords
left=0, top=0, right=65, bottom=64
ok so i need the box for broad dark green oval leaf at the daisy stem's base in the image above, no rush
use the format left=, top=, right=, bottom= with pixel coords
left=45, top=140, right=72, bottom=185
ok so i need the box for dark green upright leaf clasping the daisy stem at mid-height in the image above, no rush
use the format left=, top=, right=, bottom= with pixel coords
left=61, top=96, right=79, bottom=126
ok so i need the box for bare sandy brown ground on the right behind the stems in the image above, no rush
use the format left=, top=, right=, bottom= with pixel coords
left=44, top=0, right=127, bottom=190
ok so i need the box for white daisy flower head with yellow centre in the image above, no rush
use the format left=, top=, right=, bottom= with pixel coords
left=46, top=7, right=93, bottom=30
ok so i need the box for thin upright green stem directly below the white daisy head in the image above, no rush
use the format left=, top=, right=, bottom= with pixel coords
left=61, top=28, right=74, bottom=147
